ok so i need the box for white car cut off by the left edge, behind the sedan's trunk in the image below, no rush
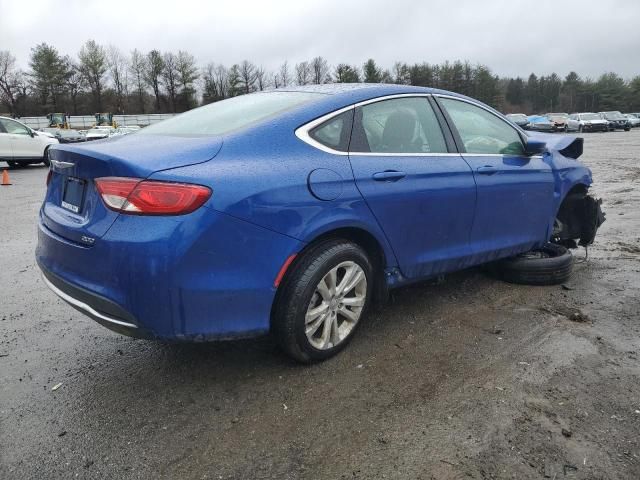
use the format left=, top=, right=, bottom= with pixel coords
left=0, top=117, right=58, bottom=167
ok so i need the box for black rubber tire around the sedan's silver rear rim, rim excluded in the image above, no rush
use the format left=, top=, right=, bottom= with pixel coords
left=271, top=239, right=374, bottom=363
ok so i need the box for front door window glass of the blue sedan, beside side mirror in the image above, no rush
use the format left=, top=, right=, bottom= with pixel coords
left=439, top=98, right=525, bottom=155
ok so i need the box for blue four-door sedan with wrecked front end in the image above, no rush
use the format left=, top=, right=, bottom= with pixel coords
left=36, top=84, right=595, bottom=362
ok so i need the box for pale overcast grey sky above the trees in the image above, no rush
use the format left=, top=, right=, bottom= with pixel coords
left=0, top=0, right=640, bottom=78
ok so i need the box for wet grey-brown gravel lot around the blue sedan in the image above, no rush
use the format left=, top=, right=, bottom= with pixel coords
left=0, top=129, right=640, bottom=480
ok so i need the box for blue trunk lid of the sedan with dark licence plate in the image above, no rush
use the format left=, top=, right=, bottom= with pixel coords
left=41, top=135, right=222, bottom=246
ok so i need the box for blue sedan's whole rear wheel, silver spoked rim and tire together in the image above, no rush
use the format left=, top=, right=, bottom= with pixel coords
left=272, top=240, right=374, bottom=363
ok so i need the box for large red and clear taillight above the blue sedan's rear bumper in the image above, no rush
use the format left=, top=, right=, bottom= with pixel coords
left=95, top=177, right=211, bottom=215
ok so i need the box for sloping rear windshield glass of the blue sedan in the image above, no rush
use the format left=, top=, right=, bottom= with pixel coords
left=139, top=92, right=324, bottom=135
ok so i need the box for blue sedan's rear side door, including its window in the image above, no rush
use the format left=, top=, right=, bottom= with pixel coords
left=349, top=96, right=476, bottom=278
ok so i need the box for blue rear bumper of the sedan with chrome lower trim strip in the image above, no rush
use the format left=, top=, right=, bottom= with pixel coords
left=36, top=208, right=302, bottom=341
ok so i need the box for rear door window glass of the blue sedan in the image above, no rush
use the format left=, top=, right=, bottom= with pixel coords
left=350, top=97, right=447, bottom=154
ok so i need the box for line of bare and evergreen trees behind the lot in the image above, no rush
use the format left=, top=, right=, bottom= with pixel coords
left=0, top=40, right=640, bottom=116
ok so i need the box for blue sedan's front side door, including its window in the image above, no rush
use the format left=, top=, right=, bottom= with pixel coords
left=437, top=97, right=555, bottom=263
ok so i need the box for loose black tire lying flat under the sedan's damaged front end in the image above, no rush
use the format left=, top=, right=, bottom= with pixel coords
left=491, top=243, right=573, bottom=285
